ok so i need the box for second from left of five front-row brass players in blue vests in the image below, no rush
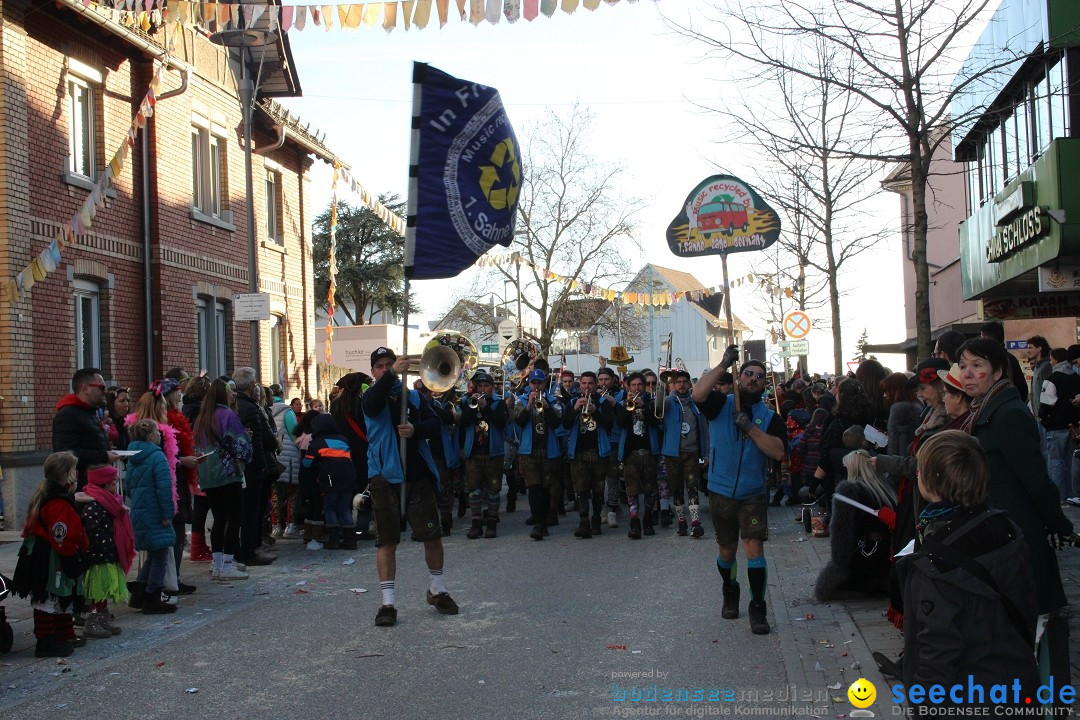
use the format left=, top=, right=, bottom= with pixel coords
left=514, top=370, right=563, bottom=540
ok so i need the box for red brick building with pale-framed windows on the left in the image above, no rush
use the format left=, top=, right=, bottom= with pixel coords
left=0, top=0, right=334, bottom=521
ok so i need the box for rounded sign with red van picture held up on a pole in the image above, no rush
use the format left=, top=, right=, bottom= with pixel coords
left=667, top=175, right=780, bottom=257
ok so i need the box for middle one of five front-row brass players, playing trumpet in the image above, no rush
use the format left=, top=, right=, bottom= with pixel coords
left=563, top=370, right=613, bottom=539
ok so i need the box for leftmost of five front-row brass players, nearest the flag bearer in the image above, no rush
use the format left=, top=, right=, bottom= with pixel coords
left=460, top=370, right=509, bottom=540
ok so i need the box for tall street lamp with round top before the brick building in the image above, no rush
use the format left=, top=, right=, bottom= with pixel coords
left=210, top=28, right=278, bottom=373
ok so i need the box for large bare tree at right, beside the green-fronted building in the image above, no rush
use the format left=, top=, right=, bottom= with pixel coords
left=669, top=0, right=1016, bottom=356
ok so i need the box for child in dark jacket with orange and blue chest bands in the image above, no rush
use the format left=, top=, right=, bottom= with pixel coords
left=300, top=412, right=356, bottom=549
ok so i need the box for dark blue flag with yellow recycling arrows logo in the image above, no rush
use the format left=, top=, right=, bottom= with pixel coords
left=405, top=63, right=522, bottom=280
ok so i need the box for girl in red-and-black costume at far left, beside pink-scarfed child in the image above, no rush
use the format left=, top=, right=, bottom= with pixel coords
left=13, top=451, right=87, bottom=657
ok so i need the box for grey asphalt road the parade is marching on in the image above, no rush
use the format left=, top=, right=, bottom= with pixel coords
left=0, top=511, right=787, bottom=720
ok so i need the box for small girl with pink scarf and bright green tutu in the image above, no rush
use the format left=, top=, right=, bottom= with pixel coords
left=75, top=465, right=135, bottom=638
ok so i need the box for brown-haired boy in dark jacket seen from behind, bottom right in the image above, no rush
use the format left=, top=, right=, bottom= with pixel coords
left=896, top=430, right=1041, bottom=707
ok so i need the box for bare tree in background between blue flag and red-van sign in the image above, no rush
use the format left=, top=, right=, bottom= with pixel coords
left=494, top=106, right=638, bottom=353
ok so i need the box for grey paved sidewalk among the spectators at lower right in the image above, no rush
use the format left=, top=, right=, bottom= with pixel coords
left=766, top=506, right=1080, bottom=717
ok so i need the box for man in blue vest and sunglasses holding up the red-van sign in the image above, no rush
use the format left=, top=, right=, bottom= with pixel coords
left=691, top=345, right=787, bottom=635
